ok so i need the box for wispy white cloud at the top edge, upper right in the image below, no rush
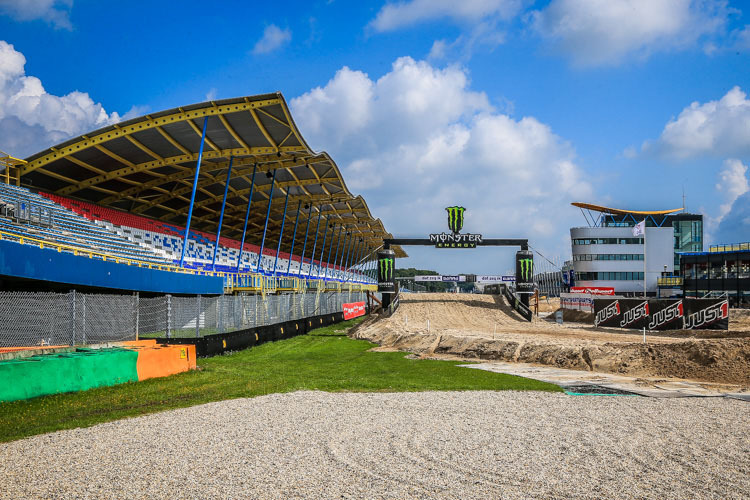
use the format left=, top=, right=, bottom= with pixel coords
left=530, top=0, right=729, bottom=66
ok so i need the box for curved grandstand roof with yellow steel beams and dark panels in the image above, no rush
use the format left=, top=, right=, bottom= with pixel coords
left=18, top=93, right=406, bottom=258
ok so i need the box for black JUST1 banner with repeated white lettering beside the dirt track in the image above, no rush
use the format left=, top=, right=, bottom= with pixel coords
left=594, top=299, right=729, bottom=330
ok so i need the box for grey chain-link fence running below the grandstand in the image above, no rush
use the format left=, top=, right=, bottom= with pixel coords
left=0, top=291, right=365, bottom=347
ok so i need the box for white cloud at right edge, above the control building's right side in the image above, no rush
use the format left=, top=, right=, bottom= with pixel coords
left=642, top=87, right=750, bottom=159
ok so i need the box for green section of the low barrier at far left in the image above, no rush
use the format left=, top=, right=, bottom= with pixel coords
left=0, top=347, right=138, bottom=401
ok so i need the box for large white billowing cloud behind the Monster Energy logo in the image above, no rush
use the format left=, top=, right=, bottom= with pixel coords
left=291, top=57, right=591, bottom=268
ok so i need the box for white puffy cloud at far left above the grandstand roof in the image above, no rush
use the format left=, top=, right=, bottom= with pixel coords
left=0, top=40, right=121, bottom=157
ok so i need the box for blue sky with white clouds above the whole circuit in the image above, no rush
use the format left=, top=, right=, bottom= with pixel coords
left=0, top=0, right=750, bottom=273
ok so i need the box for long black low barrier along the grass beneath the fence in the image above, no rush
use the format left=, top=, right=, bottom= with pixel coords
left=159, top=310, right=362, bottom=358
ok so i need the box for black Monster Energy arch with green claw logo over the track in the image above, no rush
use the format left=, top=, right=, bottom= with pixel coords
left=378, top=206, right=534, bottom=314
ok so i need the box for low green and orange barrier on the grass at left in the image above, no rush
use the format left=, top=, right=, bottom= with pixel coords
left=0, top=340, right=196, bottom=402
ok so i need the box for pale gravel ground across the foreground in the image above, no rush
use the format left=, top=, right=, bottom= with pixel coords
left=0, top=392, right=750, bottom=500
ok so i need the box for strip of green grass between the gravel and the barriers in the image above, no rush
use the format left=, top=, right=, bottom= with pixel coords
left=0, top=320, right=562, bottom=442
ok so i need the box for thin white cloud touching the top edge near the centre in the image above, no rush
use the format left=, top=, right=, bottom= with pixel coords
left=369, top=0, right=524, bottom=32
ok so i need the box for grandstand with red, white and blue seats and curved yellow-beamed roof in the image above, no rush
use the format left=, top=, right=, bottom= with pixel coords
left=0, top=93, right=406, bottom=345
